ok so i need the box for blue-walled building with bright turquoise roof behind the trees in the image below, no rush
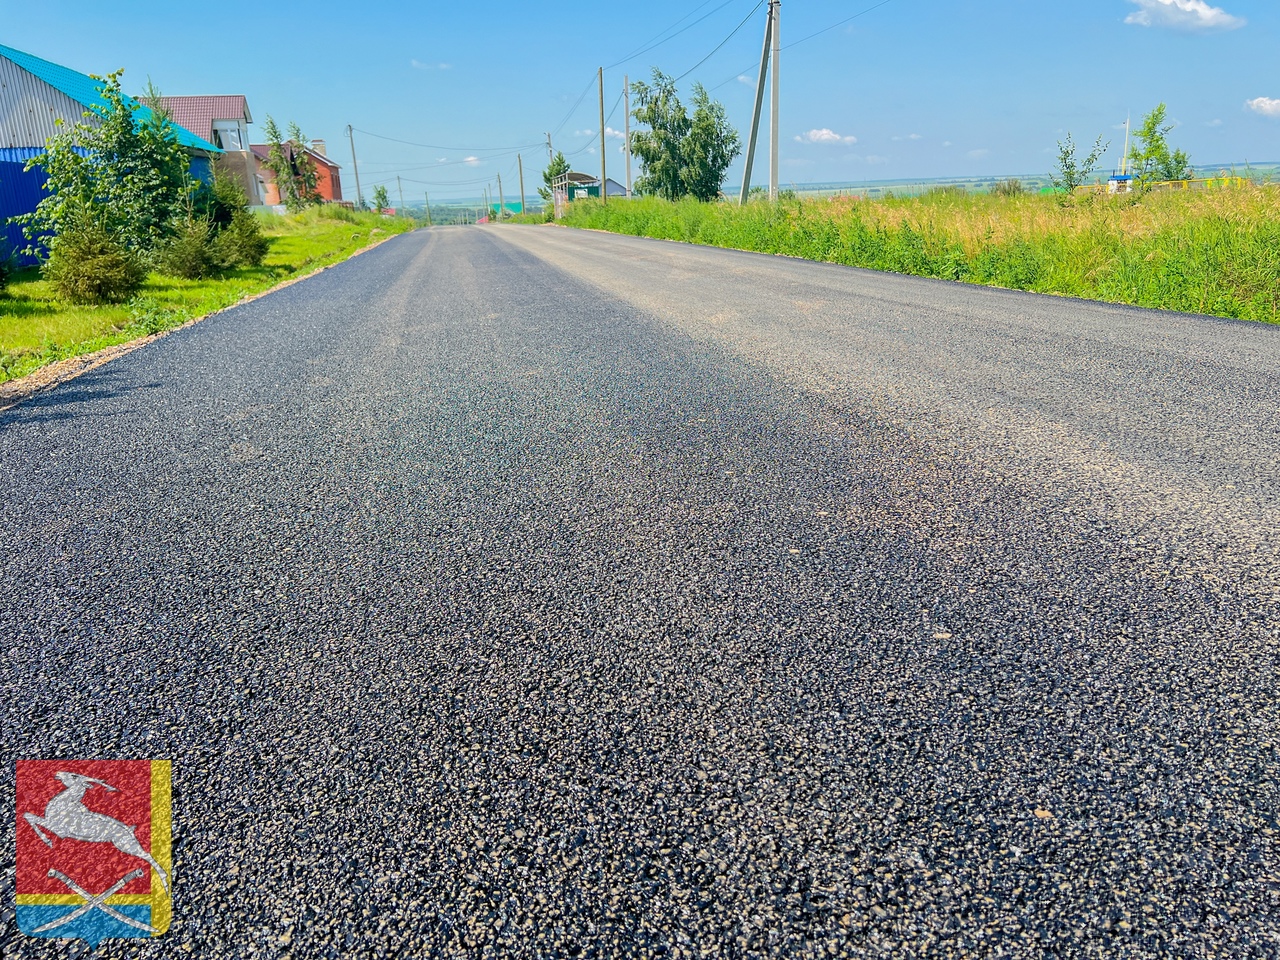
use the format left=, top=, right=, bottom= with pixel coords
left=0, top=45, right=223, bottom=265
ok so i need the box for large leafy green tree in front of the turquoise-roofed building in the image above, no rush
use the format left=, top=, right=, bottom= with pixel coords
left=15, top=70, right=198, bottom=257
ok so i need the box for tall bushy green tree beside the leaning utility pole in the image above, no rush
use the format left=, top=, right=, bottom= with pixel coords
left=631, top=68, right=742, bottom=201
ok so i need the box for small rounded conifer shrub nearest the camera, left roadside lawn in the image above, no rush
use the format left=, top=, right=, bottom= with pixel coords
left=44, top=215, right=147, bottom=303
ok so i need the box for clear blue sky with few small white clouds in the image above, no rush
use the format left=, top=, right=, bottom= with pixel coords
left=0, top=0, right=1280, bottom=202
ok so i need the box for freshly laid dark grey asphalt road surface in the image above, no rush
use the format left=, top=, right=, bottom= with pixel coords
left=0, top=227, right=1280, bottom=957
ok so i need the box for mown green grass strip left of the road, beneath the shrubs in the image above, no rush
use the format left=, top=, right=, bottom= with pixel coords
left=0, top=207, right=413, bottom=383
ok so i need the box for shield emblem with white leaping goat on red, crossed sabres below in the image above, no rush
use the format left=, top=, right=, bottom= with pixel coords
left=15, top=760, right=172, bottom=947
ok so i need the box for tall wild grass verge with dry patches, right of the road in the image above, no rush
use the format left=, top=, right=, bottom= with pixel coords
left=562, top=187, right=1280, bottom=323
